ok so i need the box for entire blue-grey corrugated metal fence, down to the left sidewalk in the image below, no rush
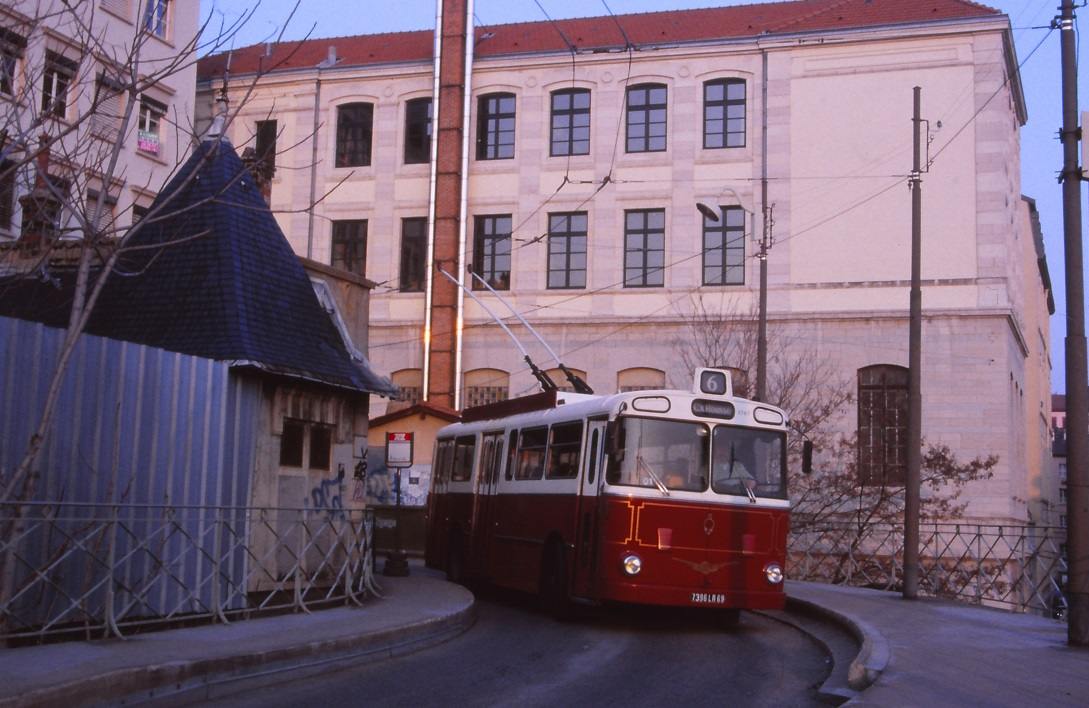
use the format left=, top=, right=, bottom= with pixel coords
left=0, top=318, right=272, bottom=634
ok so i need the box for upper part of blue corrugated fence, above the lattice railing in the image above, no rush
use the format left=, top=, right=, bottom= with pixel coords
left=0, top=317, right=260, bottom=506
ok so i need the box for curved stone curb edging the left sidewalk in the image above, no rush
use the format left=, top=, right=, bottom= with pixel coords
left=0, top=602, right=476, bottom=708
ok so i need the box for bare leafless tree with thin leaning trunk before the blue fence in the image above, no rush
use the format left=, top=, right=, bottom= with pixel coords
left=0, top=0, right=307, bottom=502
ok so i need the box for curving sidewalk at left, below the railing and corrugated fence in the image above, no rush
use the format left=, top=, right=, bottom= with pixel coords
left=0, top=566, right=474, bottom=707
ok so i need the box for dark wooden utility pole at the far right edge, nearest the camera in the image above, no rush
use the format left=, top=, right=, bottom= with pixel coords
left=1052, top=0, right=1089, bottom=647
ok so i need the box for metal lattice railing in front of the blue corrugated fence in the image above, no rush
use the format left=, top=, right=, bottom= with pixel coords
left=0, top=502, right=377, bottom=640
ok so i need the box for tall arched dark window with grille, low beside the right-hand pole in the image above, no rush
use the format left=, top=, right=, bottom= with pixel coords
left=858, top=364, right=908, bottom=486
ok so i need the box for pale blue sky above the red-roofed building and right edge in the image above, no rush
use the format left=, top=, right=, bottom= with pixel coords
left=201, top=0, right=1089, bottom=392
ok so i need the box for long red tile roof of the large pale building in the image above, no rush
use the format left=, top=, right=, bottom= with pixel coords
left=197, top=0, right=1002, bottom=78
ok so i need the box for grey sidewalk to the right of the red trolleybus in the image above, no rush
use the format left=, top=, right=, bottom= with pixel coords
left=786, top=582, right=1089, bottom=708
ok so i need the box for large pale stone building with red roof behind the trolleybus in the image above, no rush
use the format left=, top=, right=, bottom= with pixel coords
left=198, top=0, right=1050, bottom=522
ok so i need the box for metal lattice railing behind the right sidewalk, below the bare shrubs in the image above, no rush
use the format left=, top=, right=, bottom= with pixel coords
left=787, top=517, right=1067, bottom=617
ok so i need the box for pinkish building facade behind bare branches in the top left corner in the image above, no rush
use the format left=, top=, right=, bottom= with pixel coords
left=0, top=0, right=199, bottom=247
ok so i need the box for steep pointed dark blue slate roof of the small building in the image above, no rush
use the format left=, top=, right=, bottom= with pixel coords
left=1, top=139, right=395, bottom=395
